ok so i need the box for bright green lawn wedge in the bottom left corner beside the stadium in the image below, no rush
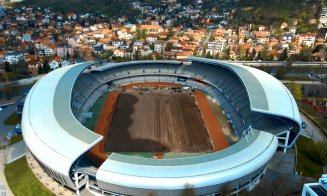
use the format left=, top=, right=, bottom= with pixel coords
left=5, top=156, right=54, bottom=196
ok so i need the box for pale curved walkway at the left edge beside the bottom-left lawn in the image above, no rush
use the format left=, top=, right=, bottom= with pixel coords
left=0, top=149, right=14, bottom=196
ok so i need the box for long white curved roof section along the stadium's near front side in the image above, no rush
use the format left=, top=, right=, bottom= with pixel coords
left=97, top=130, right=278, bottom=189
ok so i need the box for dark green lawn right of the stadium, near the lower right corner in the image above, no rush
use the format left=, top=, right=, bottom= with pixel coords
left=296, top=136, right=323, bottom=178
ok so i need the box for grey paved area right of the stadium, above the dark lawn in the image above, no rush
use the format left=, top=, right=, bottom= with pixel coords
left=300, top=113, right=327, bottom=142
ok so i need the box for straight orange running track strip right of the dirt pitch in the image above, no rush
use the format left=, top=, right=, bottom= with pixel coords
left=194, top=90, right=229, bottom=151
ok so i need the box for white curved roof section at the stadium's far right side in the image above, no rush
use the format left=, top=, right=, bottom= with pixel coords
left=188, top=57, right=301, bottom=125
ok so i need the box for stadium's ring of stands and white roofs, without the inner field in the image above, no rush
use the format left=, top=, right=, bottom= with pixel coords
left=22, top=57, right=302, bottom=195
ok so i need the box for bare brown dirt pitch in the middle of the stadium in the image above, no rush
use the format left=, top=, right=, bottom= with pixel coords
left=104, top=91, right=212, bottom=152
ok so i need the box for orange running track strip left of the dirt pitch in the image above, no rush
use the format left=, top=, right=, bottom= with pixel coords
left=88, top=92, right=119, bottom=166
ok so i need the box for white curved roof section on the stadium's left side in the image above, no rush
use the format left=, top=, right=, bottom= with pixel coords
left=22, top=63, right=102, bottom=175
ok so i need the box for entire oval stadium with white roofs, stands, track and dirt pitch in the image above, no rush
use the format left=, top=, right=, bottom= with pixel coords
left=22, top=57, right=302, bottom=195
